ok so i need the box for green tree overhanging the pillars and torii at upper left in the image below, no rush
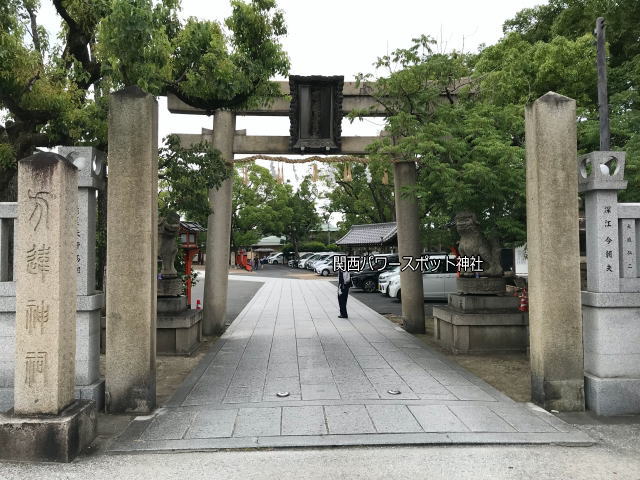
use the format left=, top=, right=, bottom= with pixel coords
left=0, top=0, right=289, bottom=200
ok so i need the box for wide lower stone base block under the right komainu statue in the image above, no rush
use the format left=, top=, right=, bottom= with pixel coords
left=433, top=306, right=529, bottom=354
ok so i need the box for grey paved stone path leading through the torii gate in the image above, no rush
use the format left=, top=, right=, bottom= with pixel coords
left=111, top=279, right=592, bottom=452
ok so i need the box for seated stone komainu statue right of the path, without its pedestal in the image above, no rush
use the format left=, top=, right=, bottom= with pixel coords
left=456, top=212, right=504, bottom=277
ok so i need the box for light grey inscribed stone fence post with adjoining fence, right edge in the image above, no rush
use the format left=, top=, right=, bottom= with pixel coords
left=578, top=151, right=640, bottom=415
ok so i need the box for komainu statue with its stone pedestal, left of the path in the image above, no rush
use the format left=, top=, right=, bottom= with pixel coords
left=156, top=213, right=202, bottom=355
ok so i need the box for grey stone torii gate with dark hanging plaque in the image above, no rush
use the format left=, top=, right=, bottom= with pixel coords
left=167, top=76, right=425, bottom=335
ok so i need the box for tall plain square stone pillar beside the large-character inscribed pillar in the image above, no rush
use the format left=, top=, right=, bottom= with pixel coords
left=106, top=87, right=158, bottom=413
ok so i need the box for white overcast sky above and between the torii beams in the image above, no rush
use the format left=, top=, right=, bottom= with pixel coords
left=41, top=0, right=544, bottom=219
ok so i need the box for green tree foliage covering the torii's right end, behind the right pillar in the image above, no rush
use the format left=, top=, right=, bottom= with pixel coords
left=353, top=0, right=640, bottom=248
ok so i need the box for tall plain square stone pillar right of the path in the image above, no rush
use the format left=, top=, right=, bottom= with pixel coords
left=525, top=92, right=584, bottom=411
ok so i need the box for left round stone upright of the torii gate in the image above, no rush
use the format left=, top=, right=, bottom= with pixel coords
left=202, top=110, right=236, bottom=335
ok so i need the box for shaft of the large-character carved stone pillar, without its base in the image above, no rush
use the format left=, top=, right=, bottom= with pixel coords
left=14, top=153, right=78, bottom=415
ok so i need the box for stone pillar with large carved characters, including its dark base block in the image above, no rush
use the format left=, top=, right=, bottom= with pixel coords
left=0, top=153, right=95, bottom=461
